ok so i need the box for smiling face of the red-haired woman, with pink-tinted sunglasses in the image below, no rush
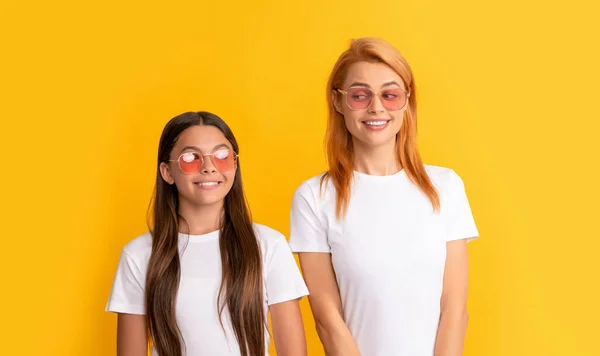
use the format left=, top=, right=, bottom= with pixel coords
left=334, top=62, right=408, bottom=147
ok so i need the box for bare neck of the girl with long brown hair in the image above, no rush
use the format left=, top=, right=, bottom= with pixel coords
left=178, top=199, right=223, bottom=235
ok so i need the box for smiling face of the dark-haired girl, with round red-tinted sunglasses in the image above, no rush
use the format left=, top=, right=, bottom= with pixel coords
left=160, top=125, right=237, bottom=206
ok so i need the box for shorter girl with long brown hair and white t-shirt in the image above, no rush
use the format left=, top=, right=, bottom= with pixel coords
left=106, top=112, right=307, bottom=356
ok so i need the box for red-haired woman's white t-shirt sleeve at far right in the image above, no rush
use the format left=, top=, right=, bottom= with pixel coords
left=446, top=171, right=479, bottom=241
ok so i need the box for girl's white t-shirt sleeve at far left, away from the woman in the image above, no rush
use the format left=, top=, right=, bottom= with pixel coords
left=106, top=249, right=146, bottom=315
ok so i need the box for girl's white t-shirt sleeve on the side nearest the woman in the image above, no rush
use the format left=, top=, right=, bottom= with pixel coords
left=265, top=234, right=308, bottom=305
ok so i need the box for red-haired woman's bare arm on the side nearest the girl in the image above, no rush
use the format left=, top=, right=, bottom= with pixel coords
left=298, top=252, right=360, bottom=356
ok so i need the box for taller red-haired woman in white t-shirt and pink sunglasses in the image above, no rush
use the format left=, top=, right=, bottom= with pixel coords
left=290, top=38, right=478, bottom=356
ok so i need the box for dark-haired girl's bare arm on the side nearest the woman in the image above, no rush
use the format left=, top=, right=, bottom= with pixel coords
left=269, top=299, right=306, bottom=356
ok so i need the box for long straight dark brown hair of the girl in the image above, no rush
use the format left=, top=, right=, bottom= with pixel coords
left=145, top=112, right=266, bottom=356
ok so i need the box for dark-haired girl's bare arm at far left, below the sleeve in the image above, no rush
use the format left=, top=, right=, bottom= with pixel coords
left=117, top=313, right=148, bottom=356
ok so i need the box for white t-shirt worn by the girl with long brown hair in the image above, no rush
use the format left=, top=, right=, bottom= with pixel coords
left=106, top=224, right=308, bottom=356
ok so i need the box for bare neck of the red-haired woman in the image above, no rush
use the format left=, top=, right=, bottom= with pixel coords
left=353, top=136, right=402, bottom=176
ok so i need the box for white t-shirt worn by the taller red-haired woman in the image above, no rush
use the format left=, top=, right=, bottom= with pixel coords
left=290, top=166, right=478, bottom=356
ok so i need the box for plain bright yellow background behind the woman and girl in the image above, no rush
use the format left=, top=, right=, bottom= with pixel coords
left=0, top=0, right=600, bottom=356
